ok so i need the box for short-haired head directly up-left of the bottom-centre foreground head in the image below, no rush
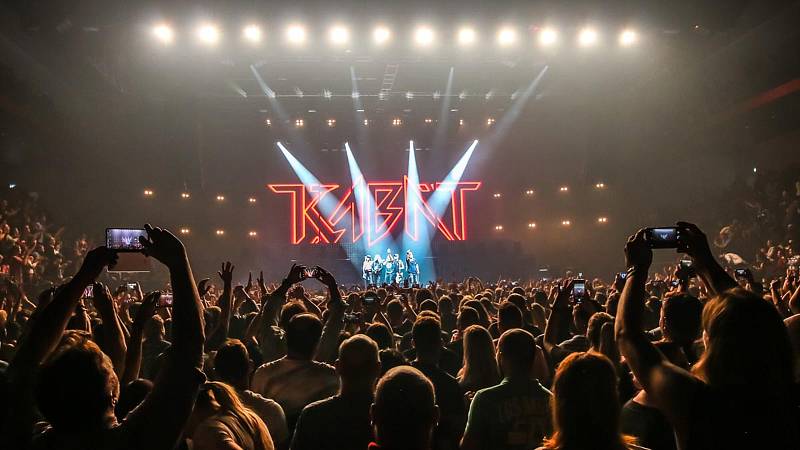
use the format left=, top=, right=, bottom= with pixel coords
left=336, top=334, right=381, bottom=393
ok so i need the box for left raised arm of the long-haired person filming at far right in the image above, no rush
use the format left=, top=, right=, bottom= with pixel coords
left=614, top=230, right=701, bottom=436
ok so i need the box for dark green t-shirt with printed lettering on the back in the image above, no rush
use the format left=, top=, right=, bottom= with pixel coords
left=465, top=378, right=552, bottom=450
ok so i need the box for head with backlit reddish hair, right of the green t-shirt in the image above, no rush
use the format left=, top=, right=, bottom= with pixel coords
left=546, top=352, right=626, bottom=449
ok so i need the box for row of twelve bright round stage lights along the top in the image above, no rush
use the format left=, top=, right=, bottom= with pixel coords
left=151, top=22, right=639, bottom=48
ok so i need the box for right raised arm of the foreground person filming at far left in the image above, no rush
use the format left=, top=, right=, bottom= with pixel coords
left=121, top=225, right=205, bottom=449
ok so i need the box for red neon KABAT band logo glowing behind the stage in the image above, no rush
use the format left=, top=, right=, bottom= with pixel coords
left=267, top=177, right=481, bottom=247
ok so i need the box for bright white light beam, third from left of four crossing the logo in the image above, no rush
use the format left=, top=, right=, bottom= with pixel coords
left=400, top=141, right=436, bottom=284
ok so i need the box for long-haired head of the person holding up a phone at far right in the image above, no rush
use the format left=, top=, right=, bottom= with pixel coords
left=693, top=288, right=794, bottom=392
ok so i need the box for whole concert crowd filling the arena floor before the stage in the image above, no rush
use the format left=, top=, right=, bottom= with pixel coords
left=0, top=181, right=800, bottom=450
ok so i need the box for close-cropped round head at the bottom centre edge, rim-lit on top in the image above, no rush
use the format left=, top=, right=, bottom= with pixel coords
left=370, top=366, right=439, bottom=450
